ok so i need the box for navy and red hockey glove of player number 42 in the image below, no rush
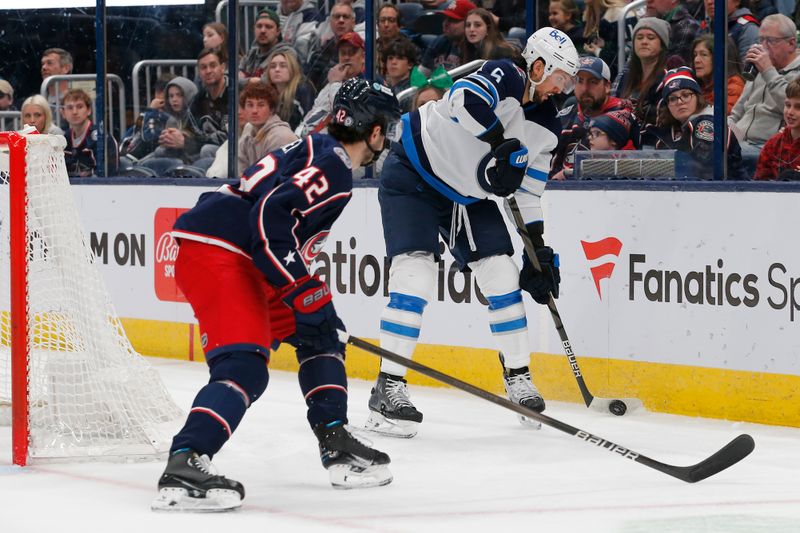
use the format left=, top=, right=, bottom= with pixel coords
left=282, top=276, right=344, bottom=354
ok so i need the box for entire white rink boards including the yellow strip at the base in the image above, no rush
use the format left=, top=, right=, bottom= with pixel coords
left=74, top=185, right=800, bottom=426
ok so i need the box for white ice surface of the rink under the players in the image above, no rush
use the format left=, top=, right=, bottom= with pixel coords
left=0, top=359, right=800, bottom=533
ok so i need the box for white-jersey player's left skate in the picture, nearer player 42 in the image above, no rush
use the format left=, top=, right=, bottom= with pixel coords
left=365, top=372, right=422, bottom=439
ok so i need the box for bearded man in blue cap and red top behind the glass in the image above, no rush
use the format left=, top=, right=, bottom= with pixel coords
left=550, top=55, right=638, bottom=180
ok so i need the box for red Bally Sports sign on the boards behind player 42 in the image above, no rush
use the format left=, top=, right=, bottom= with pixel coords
left=153, top=207, right=188, bottom=302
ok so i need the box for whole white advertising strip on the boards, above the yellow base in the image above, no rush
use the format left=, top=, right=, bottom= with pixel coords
left=73, top=186, right=800, bottom=375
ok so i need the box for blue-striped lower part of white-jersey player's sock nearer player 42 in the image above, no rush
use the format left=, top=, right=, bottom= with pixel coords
left=380, top=292, right=428, bottom=376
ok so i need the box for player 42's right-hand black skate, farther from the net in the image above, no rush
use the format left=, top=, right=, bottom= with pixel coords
left=314, top=421, right=392, bottom=489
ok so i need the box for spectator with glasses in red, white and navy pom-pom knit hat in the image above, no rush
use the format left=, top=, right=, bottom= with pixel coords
left=642, top=67, right=747, bottom=179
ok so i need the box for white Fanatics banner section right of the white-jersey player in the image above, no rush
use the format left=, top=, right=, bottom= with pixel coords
left=545, top=190, right=800, bottom=375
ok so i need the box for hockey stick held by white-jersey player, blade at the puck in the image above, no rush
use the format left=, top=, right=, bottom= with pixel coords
left=506, top=196, right=642, bottom=416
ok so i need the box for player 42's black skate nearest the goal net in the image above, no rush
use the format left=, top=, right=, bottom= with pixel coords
left=150, top=450, right=244, bottom=512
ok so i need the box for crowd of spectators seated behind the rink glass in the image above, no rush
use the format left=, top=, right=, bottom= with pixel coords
left=0, top=0, right=800, bottom=180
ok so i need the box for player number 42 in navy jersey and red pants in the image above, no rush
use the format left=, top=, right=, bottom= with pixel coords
left=153, top=79, right=400, bottom=511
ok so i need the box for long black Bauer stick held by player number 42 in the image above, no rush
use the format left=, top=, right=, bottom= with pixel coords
left=346, top=331, right=755, bottom=483
